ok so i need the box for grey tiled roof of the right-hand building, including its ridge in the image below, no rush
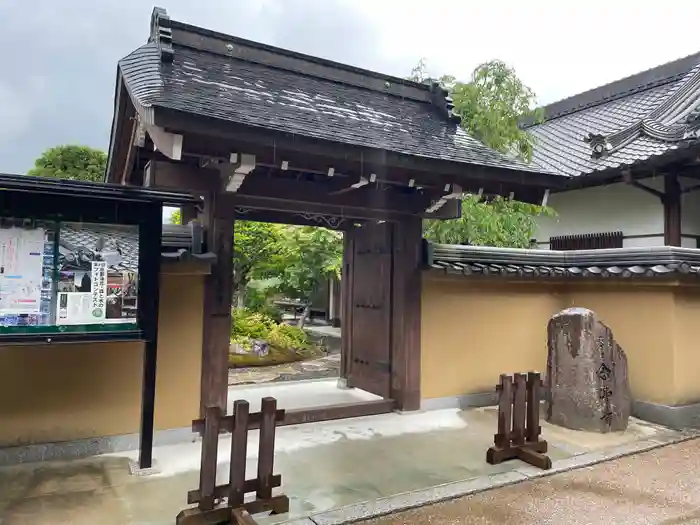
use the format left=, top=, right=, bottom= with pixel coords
left=524, top=54, right=700, bottom=177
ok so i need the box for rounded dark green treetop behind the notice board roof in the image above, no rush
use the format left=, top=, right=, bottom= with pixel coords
left=27, top=144, right=107, bottom=182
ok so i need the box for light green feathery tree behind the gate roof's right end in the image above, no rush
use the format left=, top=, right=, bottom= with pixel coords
left=409, top=59, right=554, bottom=248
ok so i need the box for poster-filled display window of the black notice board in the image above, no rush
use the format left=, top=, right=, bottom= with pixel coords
left=0, top=220, right=138, bottom=334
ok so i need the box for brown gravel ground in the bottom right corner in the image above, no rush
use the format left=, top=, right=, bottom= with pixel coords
left=362, top=439, right=700, bottom=525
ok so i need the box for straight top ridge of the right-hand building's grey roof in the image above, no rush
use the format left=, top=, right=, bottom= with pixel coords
left=522, top=52, right=700, bottom=128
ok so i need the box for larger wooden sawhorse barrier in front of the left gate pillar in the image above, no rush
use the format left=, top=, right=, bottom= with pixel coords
left=175, top=397, right=289, bottom=525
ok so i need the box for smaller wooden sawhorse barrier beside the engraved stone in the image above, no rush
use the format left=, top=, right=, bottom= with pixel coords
left=486, top=372, right=552, bottom=470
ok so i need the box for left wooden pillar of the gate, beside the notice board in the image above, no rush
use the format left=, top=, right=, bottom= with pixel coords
left=200, top=192, right=234, bottom=417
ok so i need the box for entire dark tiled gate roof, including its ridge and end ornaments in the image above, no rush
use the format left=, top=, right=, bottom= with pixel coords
left=119, top=10, right=560, bottom=178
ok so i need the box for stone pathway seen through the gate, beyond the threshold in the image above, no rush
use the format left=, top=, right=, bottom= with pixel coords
left=228, top=354, right=340, bottom=386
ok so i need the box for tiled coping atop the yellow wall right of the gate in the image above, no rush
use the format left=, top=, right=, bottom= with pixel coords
left=425, top=243, right=700, bottom=279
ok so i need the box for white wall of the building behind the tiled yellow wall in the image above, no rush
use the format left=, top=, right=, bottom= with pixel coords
left=536, top=177, right=700, bottom=249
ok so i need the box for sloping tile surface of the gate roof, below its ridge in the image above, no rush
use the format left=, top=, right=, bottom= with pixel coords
left=119, top=28, right=548, bottom=177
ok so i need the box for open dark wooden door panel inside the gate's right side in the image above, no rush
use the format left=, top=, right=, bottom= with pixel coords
left=346, top=223, right=393, bottom=398
